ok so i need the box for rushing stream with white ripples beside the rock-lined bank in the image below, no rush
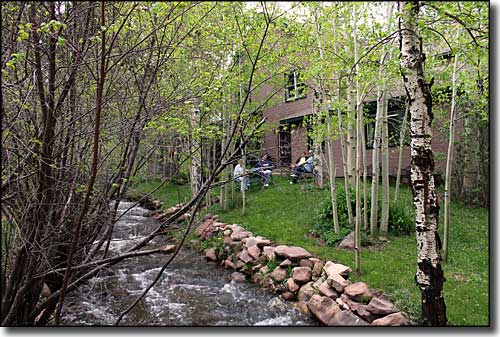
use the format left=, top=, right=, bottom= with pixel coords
left=64, top=202, right=317, bottom=326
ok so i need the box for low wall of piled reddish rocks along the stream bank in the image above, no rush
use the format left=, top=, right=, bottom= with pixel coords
left=196, top=214, right=408, bottom=326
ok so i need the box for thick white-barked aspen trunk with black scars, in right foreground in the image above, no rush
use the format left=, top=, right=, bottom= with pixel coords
left=398, top=1, right=447, bottom=326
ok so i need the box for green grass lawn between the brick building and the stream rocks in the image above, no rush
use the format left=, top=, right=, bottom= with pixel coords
left=135, top=177, right=489, bottom=326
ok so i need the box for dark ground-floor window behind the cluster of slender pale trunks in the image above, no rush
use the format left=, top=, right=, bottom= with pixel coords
left=364, top=96, right=408, bottom=149
